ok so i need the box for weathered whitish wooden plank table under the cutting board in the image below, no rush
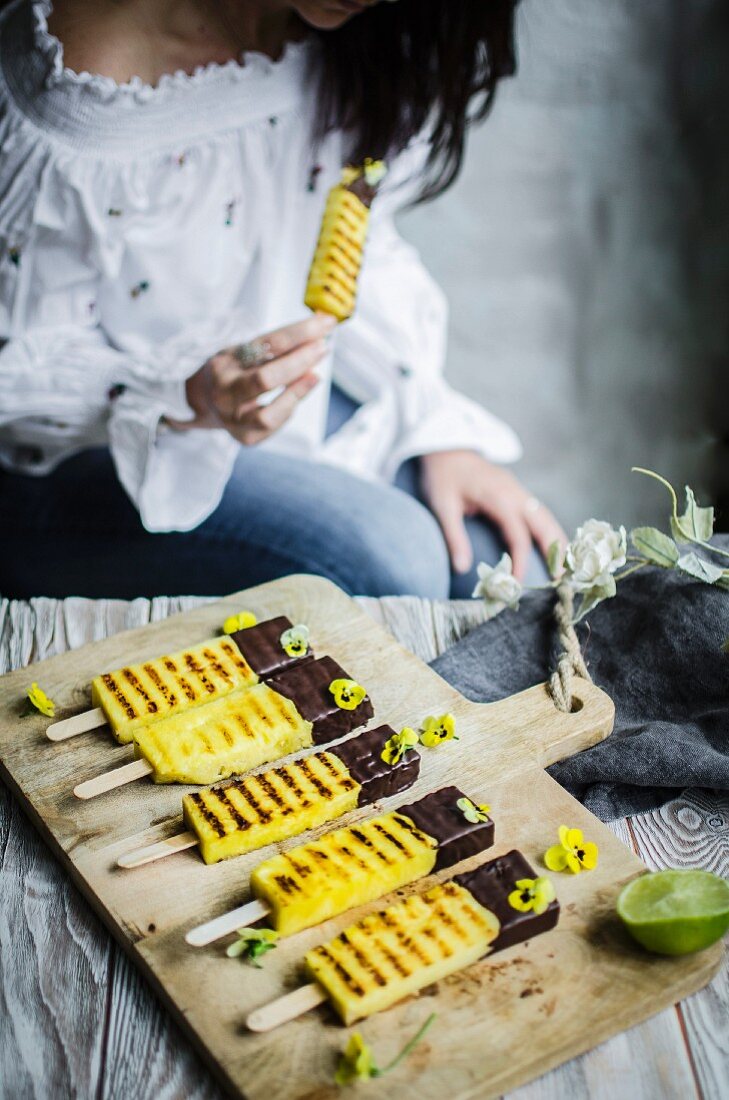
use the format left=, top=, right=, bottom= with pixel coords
left=0, top=597, right=729, bottom=1100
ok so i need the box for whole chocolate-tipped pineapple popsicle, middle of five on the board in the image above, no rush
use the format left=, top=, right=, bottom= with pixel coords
left=119, top=726, right=420, bottom=871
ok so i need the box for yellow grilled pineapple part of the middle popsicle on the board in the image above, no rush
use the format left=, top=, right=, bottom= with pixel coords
left=183, top=752, right=361, bottom=864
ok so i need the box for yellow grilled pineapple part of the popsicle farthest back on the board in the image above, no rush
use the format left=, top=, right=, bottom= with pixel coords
left=91, top=638, right=258, bottom=745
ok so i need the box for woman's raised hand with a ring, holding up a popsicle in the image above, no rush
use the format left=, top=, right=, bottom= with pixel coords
left=169, top=314, right=336, bottom=447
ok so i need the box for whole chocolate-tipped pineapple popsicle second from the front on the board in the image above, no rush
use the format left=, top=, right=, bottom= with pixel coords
left=186, top=787, right=494, bottom=947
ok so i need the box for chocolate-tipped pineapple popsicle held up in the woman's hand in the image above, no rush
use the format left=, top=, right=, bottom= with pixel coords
left=303, top=161, right=387, bottom=321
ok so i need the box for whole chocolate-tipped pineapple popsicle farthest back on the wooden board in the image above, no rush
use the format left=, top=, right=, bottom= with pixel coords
left=47, top=615, right=311, bottom=745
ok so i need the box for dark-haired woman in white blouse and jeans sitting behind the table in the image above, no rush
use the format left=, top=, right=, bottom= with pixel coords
left=0, top=0, right=562, bottom=597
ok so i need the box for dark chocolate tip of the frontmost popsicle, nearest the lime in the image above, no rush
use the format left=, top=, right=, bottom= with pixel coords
left=453, top=850, right=560, bottom=952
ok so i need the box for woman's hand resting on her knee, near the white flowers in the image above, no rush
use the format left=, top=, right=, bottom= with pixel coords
left=420, top=451, right=567, bottom=581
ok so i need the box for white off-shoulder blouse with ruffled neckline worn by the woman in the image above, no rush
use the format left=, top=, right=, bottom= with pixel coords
left=0, top=0, right=520, bottom=531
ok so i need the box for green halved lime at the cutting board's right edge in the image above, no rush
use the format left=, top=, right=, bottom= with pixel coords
left=617, top=871, right=729, bottom=955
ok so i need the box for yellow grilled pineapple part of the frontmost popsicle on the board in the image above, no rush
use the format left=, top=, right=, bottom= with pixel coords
left=305, top=882, right=499, bottom=1024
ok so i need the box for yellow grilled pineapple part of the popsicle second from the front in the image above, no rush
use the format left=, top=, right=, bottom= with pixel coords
left=251, top=813, right=438, bottom=936
